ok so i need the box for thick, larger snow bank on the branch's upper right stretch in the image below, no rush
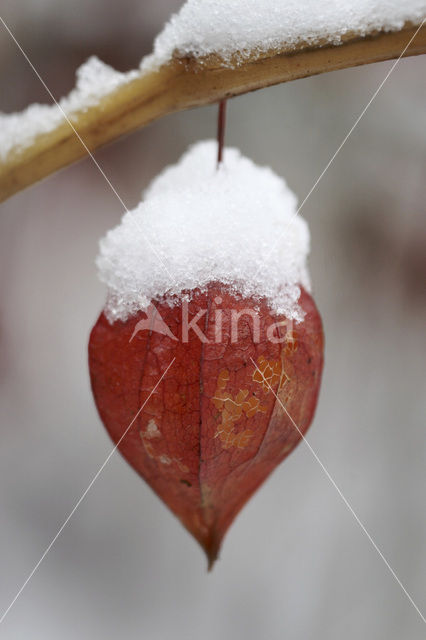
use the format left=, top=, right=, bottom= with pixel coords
left=141, top=0, right=426, bottom=69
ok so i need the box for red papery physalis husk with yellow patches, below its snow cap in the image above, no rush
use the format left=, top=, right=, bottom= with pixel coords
left=89, top=283, right=324, bottom=566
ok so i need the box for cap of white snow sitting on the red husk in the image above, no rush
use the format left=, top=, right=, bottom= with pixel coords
left=97, top=141, right=309, bottom=323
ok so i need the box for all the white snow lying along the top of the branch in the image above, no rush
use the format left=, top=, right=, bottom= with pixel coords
left=0, top=0, right=426, bottom=162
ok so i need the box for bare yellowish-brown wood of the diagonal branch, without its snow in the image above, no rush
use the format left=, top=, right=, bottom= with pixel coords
left=0, top=26, right=426, bottom=202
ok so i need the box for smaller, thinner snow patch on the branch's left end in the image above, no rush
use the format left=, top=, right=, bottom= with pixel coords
left=0, top=56, right=139, bottom=161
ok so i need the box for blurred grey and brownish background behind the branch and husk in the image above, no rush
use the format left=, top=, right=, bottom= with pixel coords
left=0, top=0, right=426, bottom=640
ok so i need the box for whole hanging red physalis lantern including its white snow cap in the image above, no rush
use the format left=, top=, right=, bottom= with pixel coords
left=89, top=141, right=323, bottom=566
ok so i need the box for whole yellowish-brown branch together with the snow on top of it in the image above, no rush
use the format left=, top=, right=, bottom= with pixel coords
left=0, top=0, right=426, bottom=201
